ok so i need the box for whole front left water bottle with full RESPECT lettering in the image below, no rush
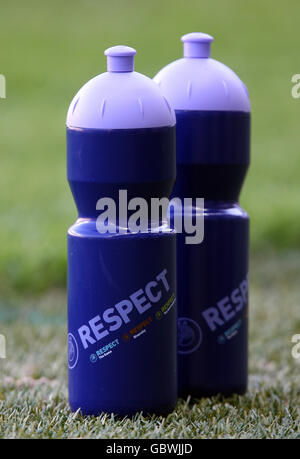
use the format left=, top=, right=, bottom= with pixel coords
left=67, top=46, right=177, bottom=415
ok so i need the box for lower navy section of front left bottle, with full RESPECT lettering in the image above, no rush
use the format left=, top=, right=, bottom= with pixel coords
left=68, top=225, right=177, bottom=416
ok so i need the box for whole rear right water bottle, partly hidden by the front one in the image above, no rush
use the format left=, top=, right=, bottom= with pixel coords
left=154, top=33, right=250, bottom=397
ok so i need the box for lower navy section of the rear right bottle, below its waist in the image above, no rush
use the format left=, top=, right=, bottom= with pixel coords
left=177, top=202, right=249, bottom=397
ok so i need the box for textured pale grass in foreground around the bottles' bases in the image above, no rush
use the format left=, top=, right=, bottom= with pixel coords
left=0, top=252, right=300, bottom=439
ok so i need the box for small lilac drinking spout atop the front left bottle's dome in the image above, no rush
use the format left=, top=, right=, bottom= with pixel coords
left=104, top=45, right=136, bottom=72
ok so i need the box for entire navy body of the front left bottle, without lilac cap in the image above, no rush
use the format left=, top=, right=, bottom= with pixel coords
left=67, top=126, right=177, bottom=416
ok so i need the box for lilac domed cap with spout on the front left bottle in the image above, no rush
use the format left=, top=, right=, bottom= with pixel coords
left=67, top=46, right=176, bottom=129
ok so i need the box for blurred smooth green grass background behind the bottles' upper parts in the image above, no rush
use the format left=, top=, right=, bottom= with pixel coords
left=0, top=0, right=300, bottom=293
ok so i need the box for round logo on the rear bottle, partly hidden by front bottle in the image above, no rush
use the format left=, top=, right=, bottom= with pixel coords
left=178, top=317, right=202, bottom=354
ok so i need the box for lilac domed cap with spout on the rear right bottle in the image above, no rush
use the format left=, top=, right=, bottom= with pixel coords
left=154, top=32, right=250, bottom=112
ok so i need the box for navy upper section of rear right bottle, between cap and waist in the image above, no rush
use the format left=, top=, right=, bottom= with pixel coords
left=173, top=110, right=250, bottom=202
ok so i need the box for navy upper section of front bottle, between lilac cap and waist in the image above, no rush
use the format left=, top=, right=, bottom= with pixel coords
left=67, top=127, right=176, bottom=218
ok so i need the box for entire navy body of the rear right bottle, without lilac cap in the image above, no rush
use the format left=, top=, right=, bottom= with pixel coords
left=173, top=110, right=250, bottom=397
